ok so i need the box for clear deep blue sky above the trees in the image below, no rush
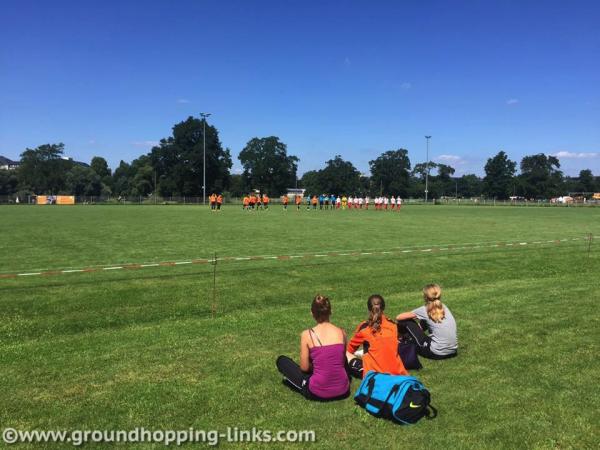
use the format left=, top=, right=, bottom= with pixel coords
left=0, top=0, right=600, bottom=175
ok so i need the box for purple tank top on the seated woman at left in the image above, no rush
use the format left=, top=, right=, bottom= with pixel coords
left=308, top=343, right=350, bottom=398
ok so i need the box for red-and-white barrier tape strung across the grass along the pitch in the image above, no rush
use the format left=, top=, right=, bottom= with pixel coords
left=0, top=238, right=587, bottom=279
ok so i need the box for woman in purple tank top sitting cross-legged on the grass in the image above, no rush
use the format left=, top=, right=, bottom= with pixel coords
left=277, top=295, right=350, bottom=400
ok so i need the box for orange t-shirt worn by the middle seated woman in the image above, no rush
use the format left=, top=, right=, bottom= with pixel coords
left=347, top=315, right=408, bottom=375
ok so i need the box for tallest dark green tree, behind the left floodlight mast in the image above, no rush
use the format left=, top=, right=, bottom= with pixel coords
left=149, top=116, right=232, bottom=195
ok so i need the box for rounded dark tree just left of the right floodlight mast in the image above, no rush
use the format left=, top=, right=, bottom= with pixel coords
left=369, top=148, right=410, bottom=197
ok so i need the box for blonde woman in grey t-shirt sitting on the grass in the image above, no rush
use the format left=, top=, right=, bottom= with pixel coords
left=396, top=284, right=458, bottom=359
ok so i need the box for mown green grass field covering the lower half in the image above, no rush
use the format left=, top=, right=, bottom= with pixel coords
left=0, top=206, right=600, bottom=449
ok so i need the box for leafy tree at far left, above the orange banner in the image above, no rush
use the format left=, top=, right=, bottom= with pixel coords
left=18, top=143, right=73, bottom=194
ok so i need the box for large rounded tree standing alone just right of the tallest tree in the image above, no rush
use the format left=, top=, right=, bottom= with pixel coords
left=238, top=136, right=299, bottom=195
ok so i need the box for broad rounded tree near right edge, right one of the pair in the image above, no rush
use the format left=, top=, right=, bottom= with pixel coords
left=519, top=153, right=563, bottom=198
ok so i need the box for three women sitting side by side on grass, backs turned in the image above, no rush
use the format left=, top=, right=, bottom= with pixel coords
left=276, top=284, right=458, bottom=400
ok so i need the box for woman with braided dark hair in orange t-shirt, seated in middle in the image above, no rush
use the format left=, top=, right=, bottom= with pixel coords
left=346, top=295, right=408, bottom=378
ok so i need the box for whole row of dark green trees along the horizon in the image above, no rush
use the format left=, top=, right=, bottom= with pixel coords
left=0, top=117, right=600, bottom=199
